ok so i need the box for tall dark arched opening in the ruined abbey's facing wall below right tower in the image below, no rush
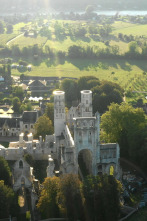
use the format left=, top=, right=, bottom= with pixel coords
left=78, top=149, right=92, bottom=177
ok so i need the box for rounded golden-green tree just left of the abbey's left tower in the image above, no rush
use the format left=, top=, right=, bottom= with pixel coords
left=34, top=115, right=53, bottom=139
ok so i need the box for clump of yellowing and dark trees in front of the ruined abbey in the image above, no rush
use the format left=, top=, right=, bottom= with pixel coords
left=37, top=174, right=122, bottom=221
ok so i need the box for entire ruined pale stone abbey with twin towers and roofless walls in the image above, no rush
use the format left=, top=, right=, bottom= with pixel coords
left=0, top=90, right=121, bottom=191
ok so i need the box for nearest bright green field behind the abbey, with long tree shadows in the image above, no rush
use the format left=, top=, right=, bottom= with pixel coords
left=12, top=59, right=147, bottom=91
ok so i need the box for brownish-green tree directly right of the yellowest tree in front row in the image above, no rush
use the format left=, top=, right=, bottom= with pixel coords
left=58, top=174, right=85, bottom=221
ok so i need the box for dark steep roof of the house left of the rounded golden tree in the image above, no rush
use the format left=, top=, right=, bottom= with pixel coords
left=22, top=111, right=38, bottom=124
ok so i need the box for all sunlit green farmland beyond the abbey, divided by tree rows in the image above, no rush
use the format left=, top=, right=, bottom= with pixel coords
left=0, top=20, right=147, bottom=101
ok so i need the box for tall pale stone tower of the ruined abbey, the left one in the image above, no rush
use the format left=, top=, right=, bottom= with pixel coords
left=53, top=91, right=65, bottom=136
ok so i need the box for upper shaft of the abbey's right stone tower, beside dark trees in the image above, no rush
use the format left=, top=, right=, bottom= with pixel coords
left=81, top=90, right=92, bottom=117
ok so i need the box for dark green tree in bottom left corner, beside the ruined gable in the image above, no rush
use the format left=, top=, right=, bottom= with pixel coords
left=0, top=180, right=15, bottom=219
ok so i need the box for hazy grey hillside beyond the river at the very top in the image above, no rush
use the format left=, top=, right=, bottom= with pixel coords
left=0, top=0, right=147, bottom=12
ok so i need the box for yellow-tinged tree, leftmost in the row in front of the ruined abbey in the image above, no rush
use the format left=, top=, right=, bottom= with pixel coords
left=37, top=177, right=59, bottom=219
